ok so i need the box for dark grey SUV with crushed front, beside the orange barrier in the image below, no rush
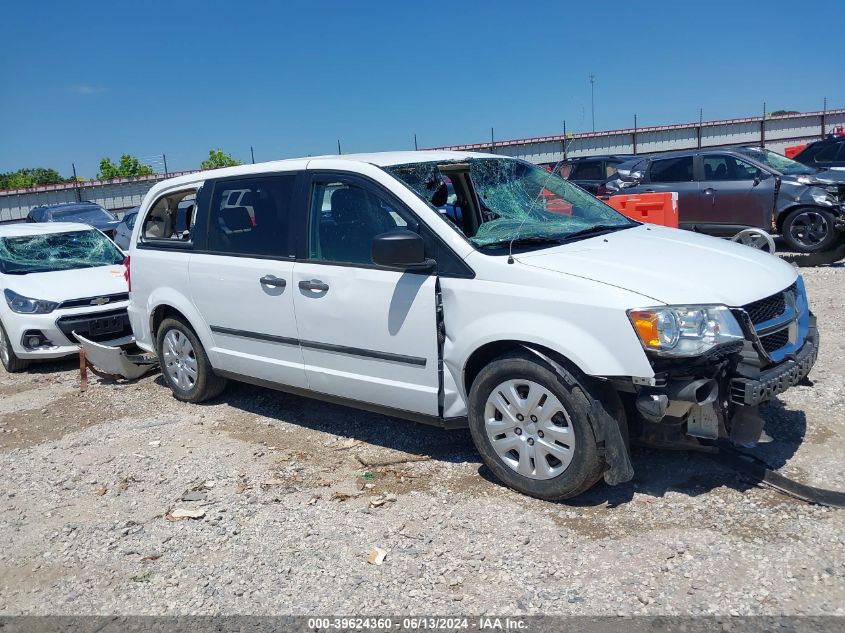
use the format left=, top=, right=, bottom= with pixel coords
left=608, top=147, right=845, bottom=253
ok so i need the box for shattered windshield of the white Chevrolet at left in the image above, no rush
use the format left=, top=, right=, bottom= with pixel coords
left=0, top=229, right=124, bottom=275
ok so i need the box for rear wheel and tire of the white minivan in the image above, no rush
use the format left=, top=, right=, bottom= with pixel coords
left=156, top=318, right=227, bottom=403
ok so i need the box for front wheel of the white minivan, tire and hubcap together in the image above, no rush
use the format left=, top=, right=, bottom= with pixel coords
left=469, top=353, right=604, bottom=501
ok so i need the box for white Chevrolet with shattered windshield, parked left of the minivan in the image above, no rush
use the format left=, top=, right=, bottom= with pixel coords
left=0, top=222, right=132, bottom=372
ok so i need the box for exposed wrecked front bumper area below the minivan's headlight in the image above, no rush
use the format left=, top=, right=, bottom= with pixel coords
left=631, top=317, right=819, bottom=447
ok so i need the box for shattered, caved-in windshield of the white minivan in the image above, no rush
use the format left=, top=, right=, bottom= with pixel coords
left=385, top=158, right=637, bottom=247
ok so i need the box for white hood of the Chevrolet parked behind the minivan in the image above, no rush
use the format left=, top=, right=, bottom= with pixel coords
left=5, top=264, right=129, bottom=301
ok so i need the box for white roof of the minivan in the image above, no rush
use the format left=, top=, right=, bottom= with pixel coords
left=145, top=150, right=498, bottom=192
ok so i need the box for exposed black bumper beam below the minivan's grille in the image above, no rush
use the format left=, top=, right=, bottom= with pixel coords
left=730, top=327, right=819, bottom=407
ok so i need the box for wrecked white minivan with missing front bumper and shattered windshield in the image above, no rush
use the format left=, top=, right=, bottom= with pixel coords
left=127, top=152, right=818, bottom=499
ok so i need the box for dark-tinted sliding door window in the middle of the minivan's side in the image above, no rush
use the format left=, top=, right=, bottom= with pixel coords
left=208, top=174, right=296, bottom=257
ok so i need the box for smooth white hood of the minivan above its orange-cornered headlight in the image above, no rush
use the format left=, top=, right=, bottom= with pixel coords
left=516, top=225, right=797, bottom=308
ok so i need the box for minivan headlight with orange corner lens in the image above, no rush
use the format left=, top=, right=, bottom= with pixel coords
left=628, top=306, right=744, bottom=356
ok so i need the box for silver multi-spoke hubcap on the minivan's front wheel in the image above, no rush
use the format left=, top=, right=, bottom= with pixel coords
left=484, top=380, right=576, bottom=479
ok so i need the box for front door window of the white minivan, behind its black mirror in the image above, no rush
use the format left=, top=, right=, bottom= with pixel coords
left=309, top=180, right=417, bottom=265
